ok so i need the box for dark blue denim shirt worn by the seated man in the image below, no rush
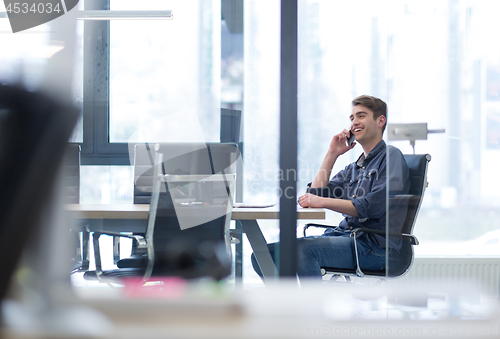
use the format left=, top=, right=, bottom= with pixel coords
left=307, top=140, right=410, bottom=249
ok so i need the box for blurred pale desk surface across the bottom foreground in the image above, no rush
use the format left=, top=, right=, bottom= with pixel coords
left=5, top=278, right=500, bottom=339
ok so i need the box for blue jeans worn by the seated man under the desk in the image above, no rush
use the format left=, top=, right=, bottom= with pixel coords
left=252, top=231, right=386, bottom=277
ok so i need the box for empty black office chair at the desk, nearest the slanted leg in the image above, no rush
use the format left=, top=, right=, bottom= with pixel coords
left=85, top=143, right=238, bottom=281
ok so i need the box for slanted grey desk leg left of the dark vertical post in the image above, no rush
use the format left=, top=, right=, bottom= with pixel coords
left=241, top=220, right=278, bottom=280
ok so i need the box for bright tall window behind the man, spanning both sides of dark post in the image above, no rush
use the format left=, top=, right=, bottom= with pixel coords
left=231, top=0, right=500, bottom=266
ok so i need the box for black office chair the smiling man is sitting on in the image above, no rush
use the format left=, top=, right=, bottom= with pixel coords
left=304, top=154, right=431, bottom=281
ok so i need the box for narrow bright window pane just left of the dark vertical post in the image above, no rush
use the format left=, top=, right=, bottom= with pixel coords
left=243, top=0, right=280, bottom=203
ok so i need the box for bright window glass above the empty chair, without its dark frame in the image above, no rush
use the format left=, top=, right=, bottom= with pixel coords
left=109, top=0, right=220, bottom=142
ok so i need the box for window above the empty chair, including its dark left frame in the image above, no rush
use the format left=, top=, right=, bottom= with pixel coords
left=82, top=0, right=220, bottom=165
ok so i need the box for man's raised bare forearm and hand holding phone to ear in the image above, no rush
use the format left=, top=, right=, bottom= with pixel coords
left=311, top=129, right=356, bottom=188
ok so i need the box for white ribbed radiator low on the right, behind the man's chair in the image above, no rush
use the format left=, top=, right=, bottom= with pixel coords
left=396, top=257, right=500, bottom=297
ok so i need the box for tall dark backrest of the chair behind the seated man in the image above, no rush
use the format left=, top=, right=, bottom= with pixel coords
left=388, top=154, right=431, bottom=277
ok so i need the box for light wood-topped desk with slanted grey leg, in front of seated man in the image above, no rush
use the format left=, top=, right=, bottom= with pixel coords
left=66, top=204, right=325, bottom=278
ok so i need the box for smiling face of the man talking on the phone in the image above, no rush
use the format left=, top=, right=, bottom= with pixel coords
left=349, top=105, right=385, bottom=145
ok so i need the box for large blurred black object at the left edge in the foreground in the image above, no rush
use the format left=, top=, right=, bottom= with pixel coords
left=0, top=84, right=79, bottom=301
